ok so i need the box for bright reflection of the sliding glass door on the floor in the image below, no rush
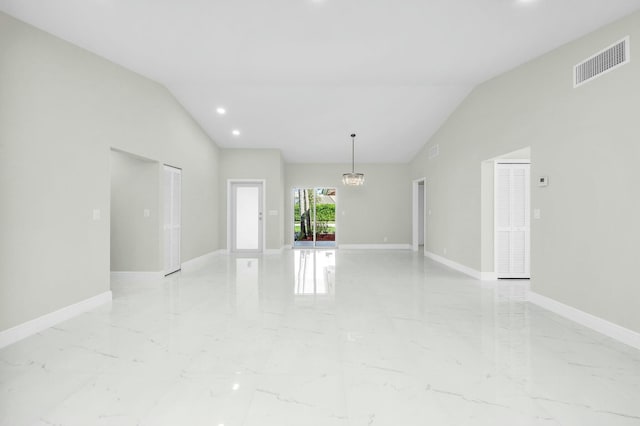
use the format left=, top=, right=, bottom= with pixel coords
left=293, top=250, right=336, bottom=297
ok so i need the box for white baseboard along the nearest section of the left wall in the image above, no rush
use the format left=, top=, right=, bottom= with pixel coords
left=0, top=291, right=112, bottom=348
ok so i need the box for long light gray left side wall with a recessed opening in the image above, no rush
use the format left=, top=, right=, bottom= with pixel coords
left=0, top=13, right=219, bottom=330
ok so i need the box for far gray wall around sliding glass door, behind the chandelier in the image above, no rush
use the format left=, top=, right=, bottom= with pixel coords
left=284, top=164, right=412, bottom=245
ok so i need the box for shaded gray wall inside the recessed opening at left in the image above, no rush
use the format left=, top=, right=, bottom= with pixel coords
left=110, top=151, right=163, bottom=272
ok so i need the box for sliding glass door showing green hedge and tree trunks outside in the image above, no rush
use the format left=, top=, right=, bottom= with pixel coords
left=293, top=188, right=336, bottom=247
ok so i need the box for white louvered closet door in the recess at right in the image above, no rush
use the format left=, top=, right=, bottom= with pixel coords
left=495, top=164, right=530, bottom=278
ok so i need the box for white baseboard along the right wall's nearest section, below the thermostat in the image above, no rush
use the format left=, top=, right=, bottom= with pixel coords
left=527, top=291, right=640, bottom=349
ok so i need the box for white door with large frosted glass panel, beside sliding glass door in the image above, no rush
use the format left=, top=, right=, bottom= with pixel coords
left=230, top=182, right=263, bottom=252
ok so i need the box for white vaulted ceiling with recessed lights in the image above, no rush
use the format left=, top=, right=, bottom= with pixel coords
left=0, top=0, right=640, bottom=163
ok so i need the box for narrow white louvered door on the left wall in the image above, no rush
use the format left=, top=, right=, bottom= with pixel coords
left=164, top=166, right=182, bottom=275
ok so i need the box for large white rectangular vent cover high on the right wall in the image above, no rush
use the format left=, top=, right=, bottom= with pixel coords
left=573, top=36, right=631, bottom=87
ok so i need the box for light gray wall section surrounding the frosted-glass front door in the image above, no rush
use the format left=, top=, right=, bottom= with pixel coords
left=220, top=149, right=284, bottom=250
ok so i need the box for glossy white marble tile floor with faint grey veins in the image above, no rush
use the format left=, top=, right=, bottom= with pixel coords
left=0, top=250, right=640, bottom=426
